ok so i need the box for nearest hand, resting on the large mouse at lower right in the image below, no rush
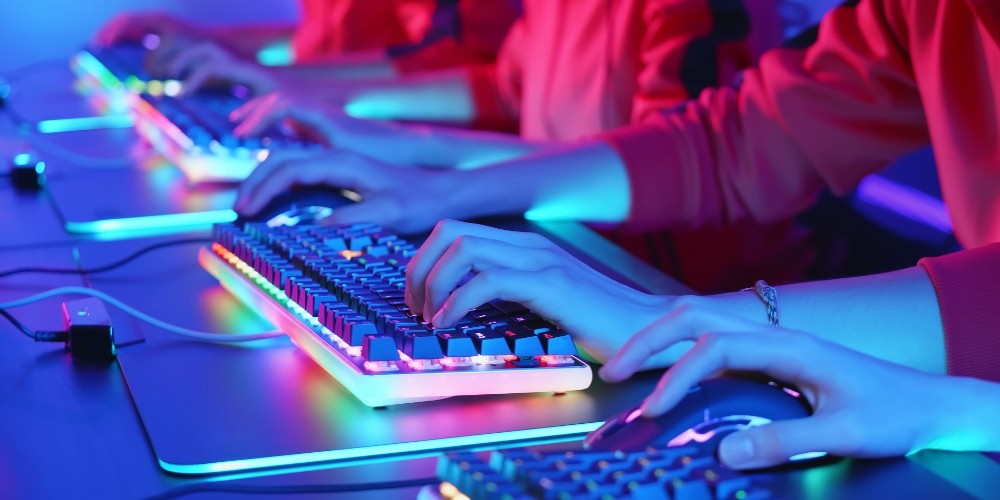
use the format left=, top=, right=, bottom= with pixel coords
left=600, top=305, right=962, bottom=469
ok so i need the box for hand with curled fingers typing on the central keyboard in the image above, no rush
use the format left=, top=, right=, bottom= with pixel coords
left=406, top=220, right=672, bottom=362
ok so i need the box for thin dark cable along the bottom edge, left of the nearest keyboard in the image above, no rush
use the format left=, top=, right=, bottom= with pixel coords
left=149, top=477, right=441, bottom=499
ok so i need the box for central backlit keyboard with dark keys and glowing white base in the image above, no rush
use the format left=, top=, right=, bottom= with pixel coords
left=199, top=223, right=592, bottom=406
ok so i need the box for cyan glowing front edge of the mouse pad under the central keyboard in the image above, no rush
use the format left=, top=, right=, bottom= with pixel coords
left=157, top=422, right=603, bottom=474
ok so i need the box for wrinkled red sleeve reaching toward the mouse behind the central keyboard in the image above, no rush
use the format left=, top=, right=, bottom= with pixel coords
left=604, top=0, right=929, bottom=230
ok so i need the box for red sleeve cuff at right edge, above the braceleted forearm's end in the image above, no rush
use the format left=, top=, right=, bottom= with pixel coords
left=920, top=243, right=1000, bottom=382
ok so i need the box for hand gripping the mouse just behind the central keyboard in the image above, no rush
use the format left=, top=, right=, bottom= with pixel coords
left=233, top=151, right=454, bottom=234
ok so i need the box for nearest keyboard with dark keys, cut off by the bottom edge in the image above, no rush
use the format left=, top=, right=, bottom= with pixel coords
left=434, top=445, right=777, bottom=500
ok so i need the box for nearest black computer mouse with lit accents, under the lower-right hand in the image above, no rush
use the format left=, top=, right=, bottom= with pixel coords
left=584, top=377, right=812, bottom=452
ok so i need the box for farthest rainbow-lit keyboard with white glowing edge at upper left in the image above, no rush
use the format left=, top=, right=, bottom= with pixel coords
left=72, top=45, right=324, bottom=183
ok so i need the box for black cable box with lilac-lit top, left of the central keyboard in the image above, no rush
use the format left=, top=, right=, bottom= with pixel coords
left=62, top=298, right=115, bottom=362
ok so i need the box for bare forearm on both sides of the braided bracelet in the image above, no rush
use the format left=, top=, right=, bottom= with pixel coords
left=695, top=267, right=946, bottom=373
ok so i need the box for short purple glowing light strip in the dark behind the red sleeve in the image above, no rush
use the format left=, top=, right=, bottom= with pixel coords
left=857, top=175, right=952, bottom=233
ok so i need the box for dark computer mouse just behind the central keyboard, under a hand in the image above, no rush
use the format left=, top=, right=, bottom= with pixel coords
left=236, top=187, right=356, bottom=227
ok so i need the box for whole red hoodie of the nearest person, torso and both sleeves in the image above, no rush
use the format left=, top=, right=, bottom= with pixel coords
left=605, top=0, right=1000, bottom=381
